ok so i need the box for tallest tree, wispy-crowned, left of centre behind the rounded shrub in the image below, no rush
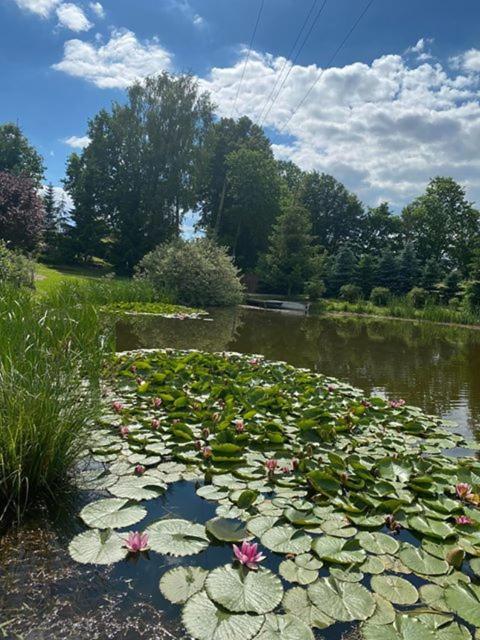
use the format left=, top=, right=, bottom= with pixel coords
left=65, top=73, right=212, bottom=274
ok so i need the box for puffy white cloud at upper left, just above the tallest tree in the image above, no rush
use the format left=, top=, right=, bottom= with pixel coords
left=53, top=30, right=172, bottom=89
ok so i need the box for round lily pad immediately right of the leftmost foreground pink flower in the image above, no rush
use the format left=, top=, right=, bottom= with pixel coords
left=145, top=518, right=209, bottom=556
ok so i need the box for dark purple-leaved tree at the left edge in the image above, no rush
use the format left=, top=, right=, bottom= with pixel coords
left=0, top=171, right=45, bottom=251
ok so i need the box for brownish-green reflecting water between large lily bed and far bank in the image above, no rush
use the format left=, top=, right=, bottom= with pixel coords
left=117, top=308, right=480, bottom=436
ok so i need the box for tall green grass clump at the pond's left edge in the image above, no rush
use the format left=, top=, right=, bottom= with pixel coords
left=0, top=285, right=112, bottom=523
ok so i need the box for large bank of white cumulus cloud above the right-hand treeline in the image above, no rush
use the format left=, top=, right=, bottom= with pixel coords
left=201, top=48, right=480, bottom=207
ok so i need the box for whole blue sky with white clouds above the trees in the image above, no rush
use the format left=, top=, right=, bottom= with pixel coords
left=0, top=0, right=480, bottom=216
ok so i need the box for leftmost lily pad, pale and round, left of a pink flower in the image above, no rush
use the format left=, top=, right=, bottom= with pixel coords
left=68, top=529, right=128, bottom=564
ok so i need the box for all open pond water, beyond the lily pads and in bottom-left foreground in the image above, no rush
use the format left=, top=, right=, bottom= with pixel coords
left=0, top=308, right=480, bottom=640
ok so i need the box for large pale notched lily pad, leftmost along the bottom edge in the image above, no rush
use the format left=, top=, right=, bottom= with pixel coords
left=182, top=591, right=264, bottom=640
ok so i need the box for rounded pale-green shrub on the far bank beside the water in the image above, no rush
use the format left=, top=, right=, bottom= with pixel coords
left=136, top=238, right=243, bottom=307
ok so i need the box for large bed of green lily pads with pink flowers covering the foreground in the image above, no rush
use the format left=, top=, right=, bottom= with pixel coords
left=70, top=350, right=480, bottom=640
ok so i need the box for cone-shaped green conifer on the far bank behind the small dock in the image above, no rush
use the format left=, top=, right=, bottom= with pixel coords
left=261, top=204, right=316, bottom=295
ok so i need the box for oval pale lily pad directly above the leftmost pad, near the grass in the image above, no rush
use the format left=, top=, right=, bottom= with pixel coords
left=80, top=498, right=147, bottom=529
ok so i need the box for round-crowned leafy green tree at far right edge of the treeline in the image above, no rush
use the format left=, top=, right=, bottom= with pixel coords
left=402, top=177, right=480, bottom=275
